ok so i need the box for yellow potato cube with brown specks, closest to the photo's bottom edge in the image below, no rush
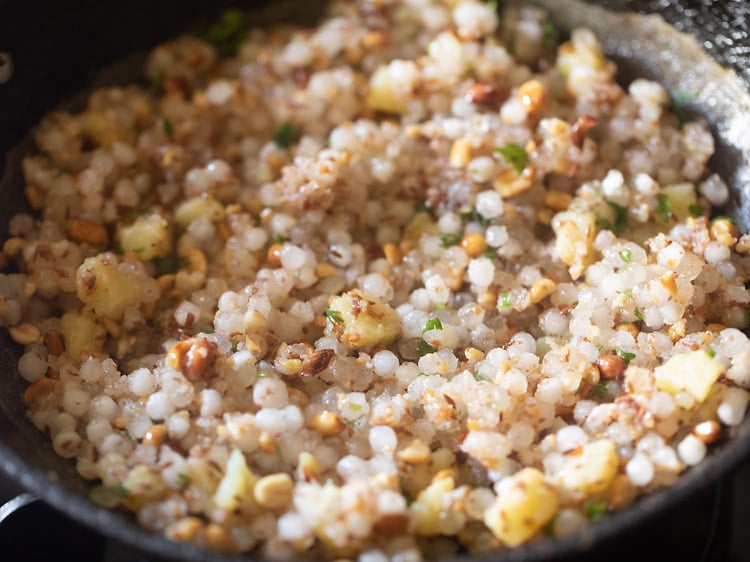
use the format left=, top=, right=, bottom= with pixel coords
left=484, top=468, right=560, bottom=546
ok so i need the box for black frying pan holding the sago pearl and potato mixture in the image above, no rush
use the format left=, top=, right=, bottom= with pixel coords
left=0, top=0, right=750, bottom=562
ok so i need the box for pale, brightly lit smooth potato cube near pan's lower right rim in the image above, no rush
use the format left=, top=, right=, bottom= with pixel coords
left=654, top=349, right=724, bottom=402
